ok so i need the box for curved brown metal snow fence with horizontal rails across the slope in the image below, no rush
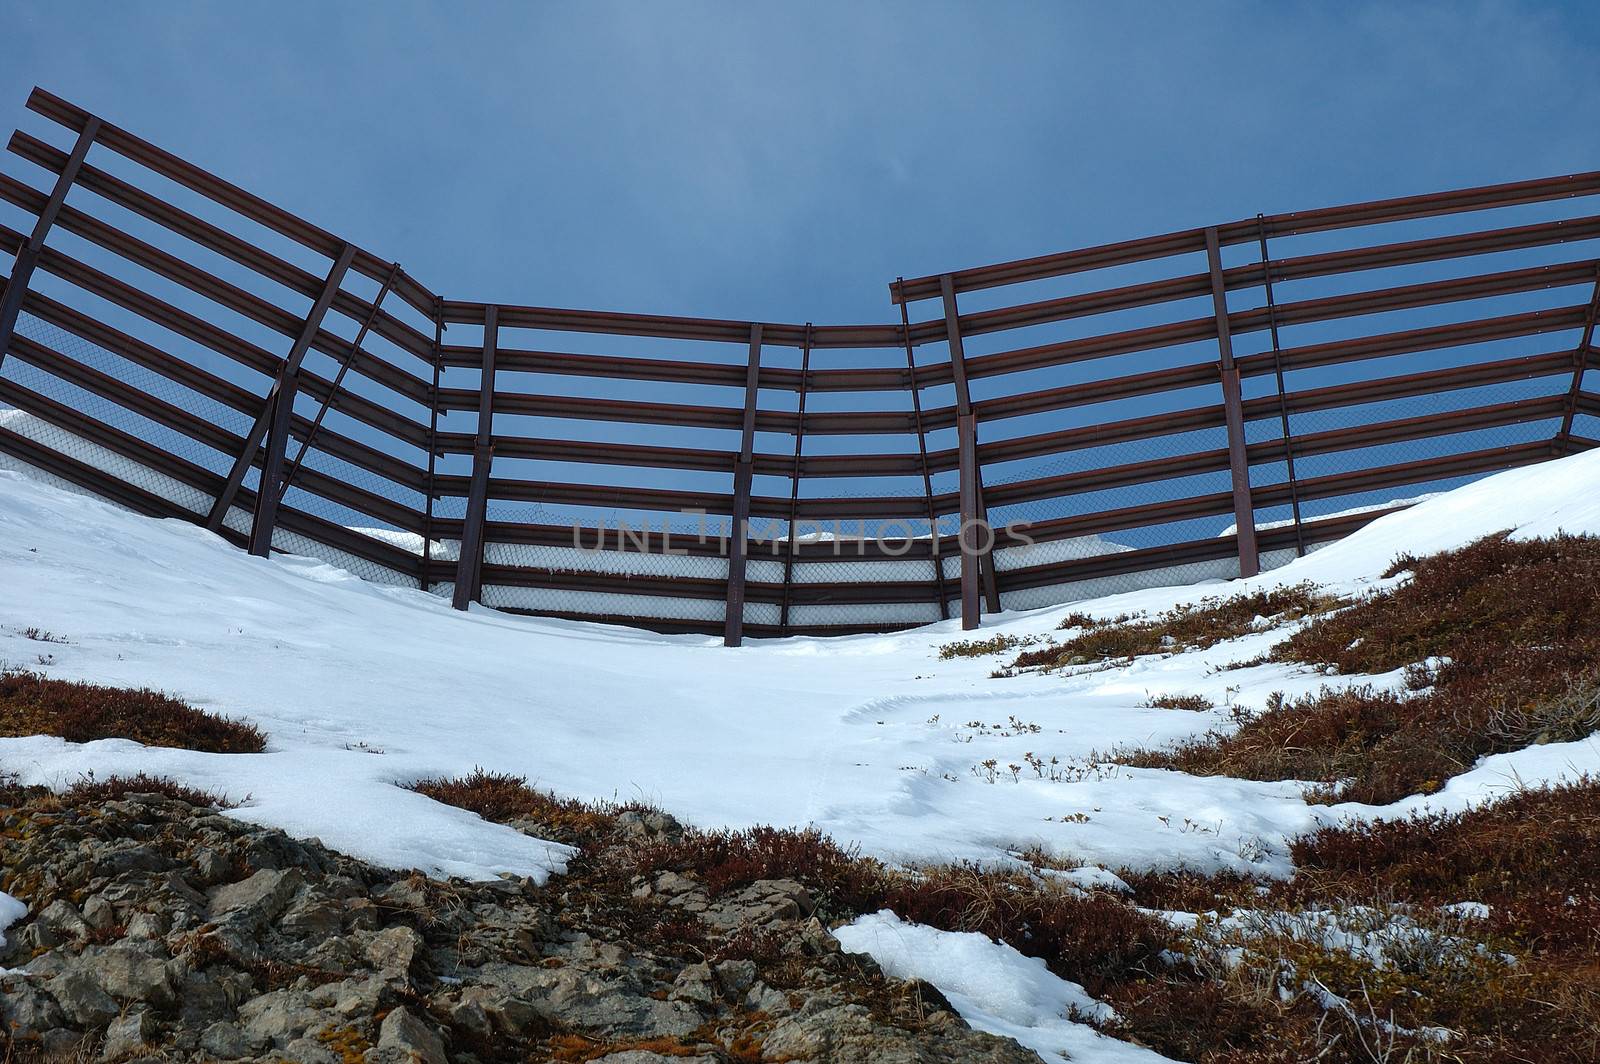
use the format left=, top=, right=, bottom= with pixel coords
left=0, top=90, right=1600, bottom=645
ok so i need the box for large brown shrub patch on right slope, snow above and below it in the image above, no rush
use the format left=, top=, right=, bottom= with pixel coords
left=1117, top=534, right=1600, bottom=803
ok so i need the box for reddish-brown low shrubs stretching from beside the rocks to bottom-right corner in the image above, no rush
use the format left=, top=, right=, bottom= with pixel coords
left=419, top=773, right=1600, bottom=1064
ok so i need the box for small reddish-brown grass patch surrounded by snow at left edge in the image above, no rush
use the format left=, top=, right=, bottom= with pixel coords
left=0, top=672, right=267, bottom=754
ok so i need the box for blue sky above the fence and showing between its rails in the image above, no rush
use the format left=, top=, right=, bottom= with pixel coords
left=0, top=2, right=1600, bottom=560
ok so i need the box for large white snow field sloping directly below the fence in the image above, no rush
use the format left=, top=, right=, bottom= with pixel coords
left=0, top=453, right=1600, bottom=875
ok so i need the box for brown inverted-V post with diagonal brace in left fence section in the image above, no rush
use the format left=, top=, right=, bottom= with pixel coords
left=206, top=243, right=355, bottom=558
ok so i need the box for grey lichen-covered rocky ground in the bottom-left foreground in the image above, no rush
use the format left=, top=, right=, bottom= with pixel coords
left=0, top=789, right=1037, bottom=1064
